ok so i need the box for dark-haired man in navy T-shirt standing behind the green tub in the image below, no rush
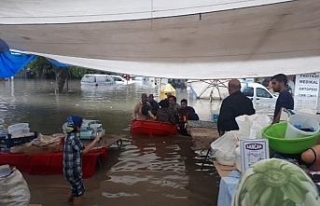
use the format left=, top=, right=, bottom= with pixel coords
left=271, top=74, right=294, bottom=124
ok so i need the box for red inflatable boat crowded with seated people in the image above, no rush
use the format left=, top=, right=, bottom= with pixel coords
left=131, top=120, right=178, bottom=136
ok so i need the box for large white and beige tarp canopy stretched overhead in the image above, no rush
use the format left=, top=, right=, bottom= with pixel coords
left=0, top=0, right=320, bottom=79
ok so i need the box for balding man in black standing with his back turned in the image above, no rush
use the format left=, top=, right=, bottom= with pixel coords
left=218, top=79, right=255, bottom=136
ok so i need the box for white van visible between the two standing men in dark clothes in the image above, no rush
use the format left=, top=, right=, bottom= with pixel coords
left=241, top=82, right=278, bottom=112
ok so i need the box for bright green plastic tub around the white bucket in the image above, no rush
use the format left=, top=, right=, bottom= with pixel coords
left=262, top=122, right=320, bottom=154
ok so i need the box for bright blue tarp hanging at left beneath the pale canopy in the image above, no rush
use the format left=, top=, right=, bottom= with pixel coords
left=0, top=39, right=69, bottom=78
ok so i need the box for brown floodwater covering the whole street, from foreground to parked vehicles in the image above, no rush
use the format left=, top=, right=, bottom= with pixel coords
left=0, top=79, right=220, bottom=206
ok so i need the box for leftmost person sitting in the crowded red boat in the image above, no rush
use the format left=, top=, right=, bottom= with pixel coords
left=132, top=93, right=156, bottom=120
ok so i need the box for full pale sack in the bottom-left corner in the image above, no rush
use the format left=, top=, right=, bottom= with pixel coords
left=0, top=165, right=31, bottom=206
